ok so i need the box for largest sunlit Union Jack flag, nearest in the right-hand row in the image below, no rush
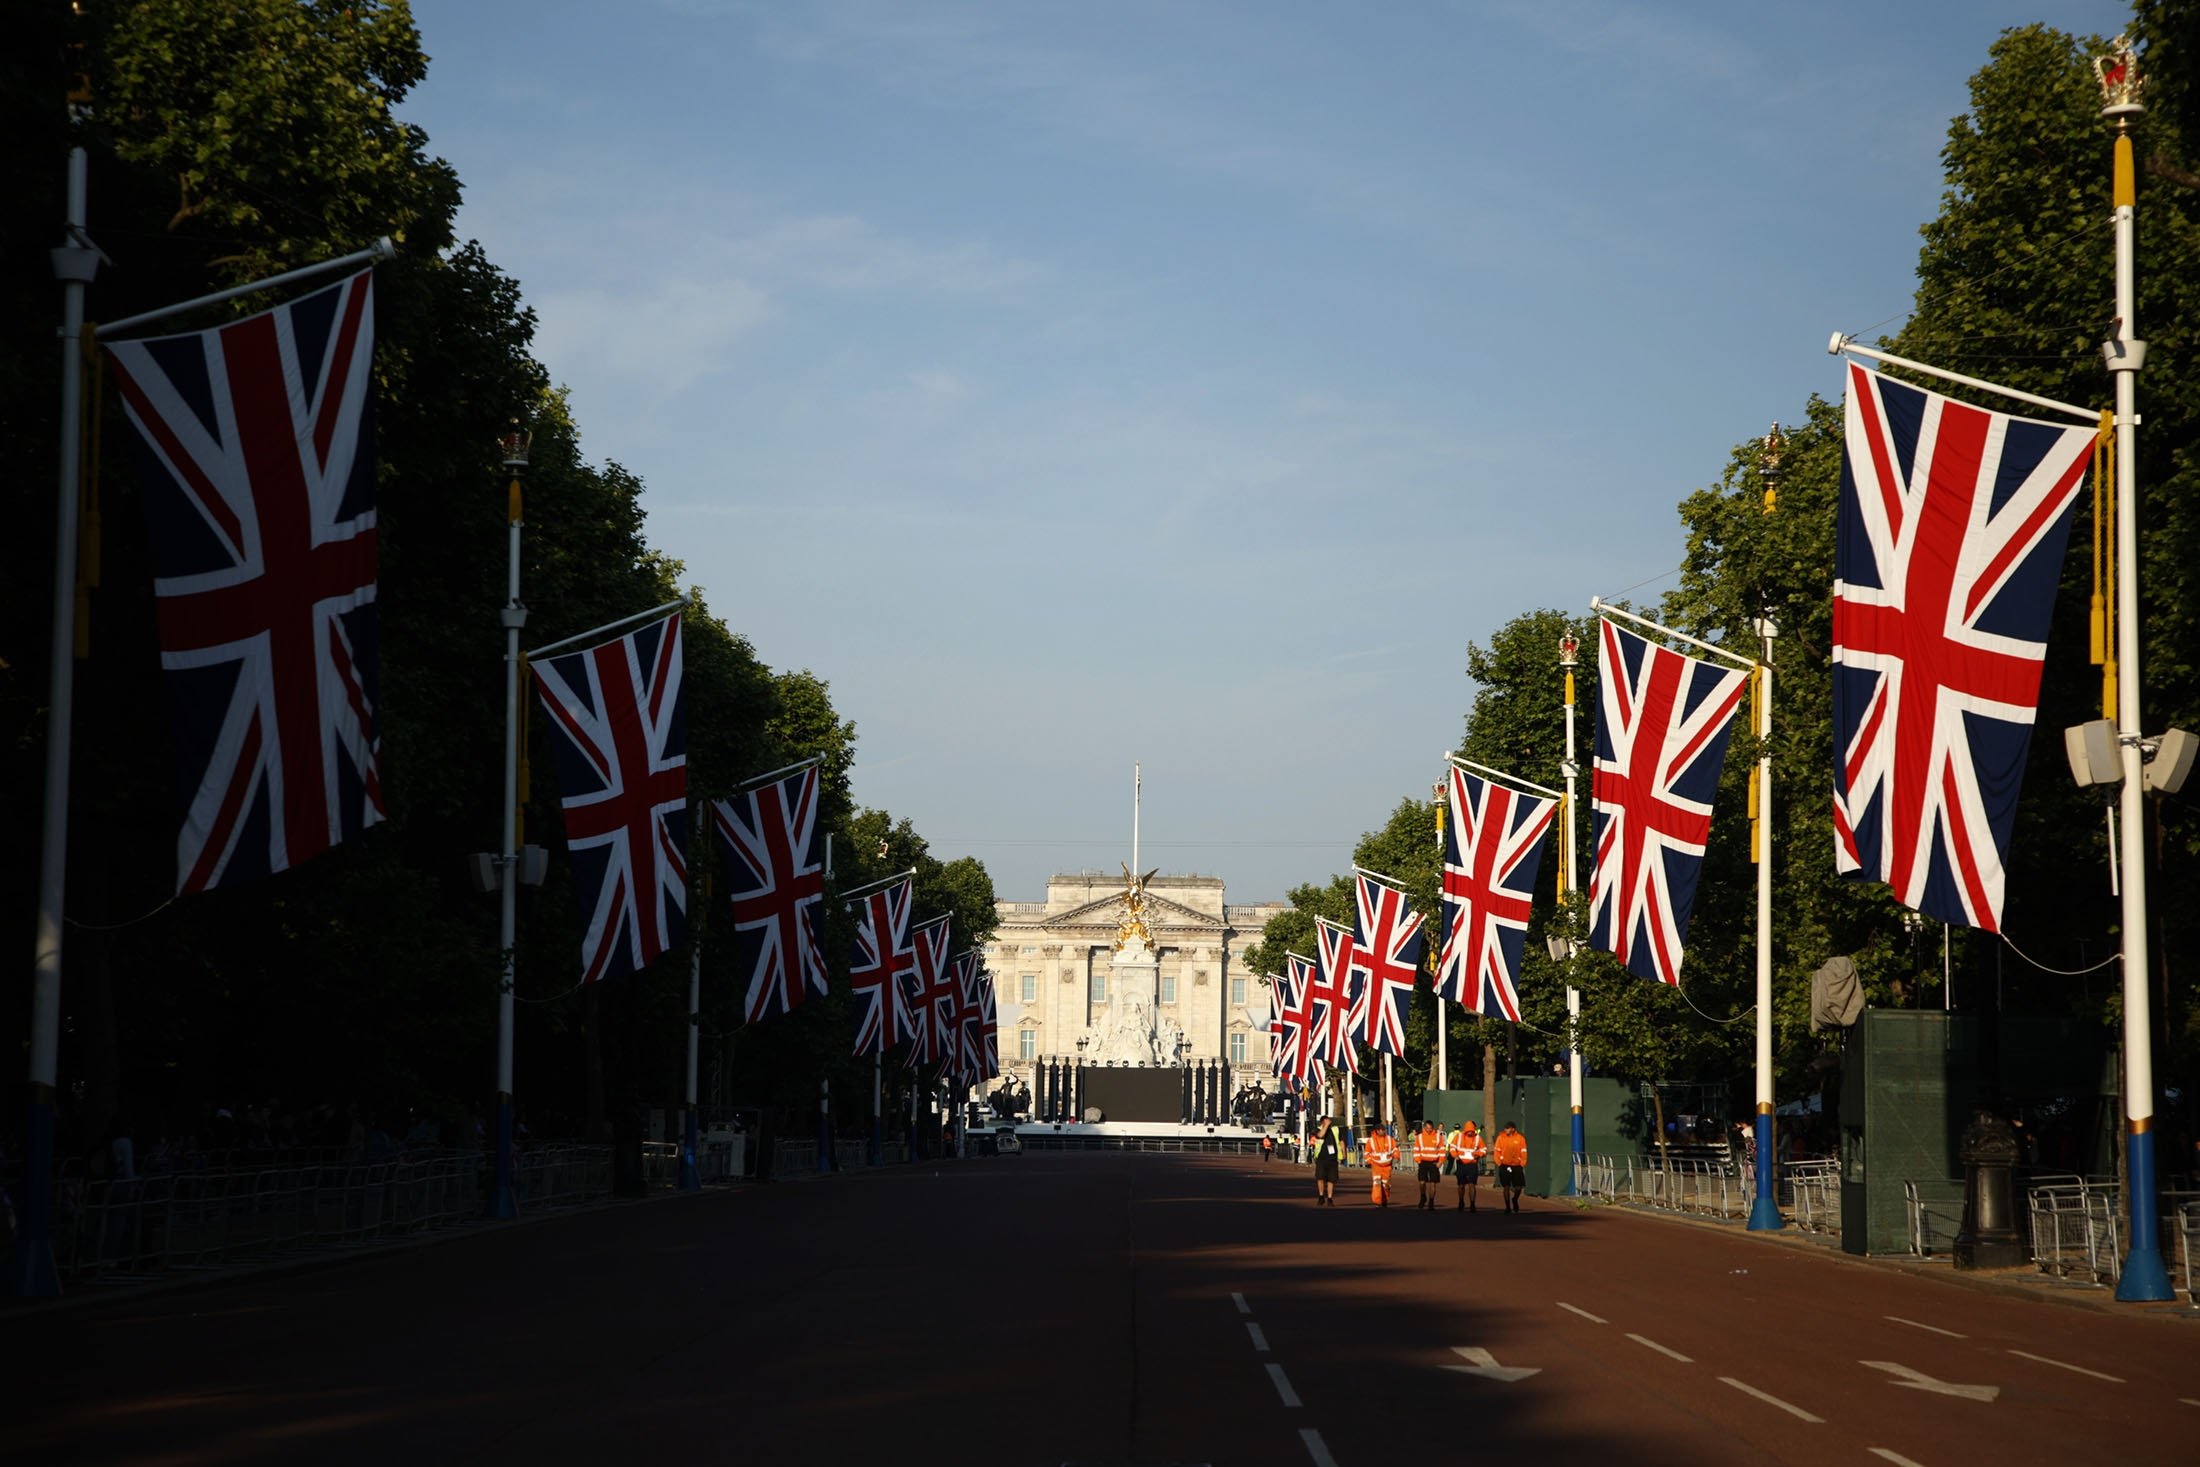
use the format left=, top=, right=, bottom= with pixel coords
left=1833, top=363, right=2094, bottom=933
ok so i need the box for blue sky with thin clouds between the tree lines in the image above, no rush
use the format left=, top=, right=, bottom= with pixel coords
left=403, top=0, right=2127, bottom=900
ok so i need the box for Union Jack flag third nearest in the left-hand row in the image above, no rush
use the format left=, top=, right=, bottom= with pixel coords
left=711, top=763, right=825, bottom=1023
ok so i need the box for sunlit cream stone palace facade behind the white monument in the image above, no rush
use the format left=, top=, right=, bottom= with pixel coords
left=986, top=871, right=1285, bottom=1080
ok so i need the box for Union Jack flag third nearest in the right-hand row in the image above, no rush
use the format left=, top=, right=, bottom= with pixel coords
left=1437, top=765, right=1558, bottom=1023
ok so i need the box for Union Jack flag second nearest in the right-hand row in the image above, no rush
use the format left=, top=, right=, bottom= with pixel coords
left=1588, top=618, right=1749, bottom=988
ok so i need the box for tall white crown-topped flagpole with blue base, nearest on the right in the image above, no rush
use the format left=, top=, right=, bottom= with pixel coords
left=2092, top=35, right=2176, bottom=1302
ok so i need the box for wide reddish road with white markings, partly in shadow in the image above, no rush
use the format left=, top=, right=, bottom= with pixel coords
left=0, top=1155, right=2200, bottom=1467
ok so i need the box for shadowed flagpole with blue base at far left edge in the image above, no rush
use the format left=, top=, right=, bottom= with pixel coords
left=7, top=147, right=99, bottom=1298
